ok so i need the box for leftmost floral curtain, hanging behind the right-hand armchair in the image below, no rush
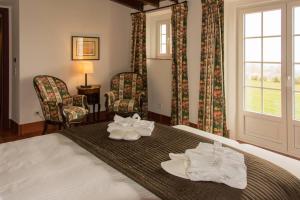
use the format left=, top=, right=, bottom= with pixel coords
left=131, top=12, right=148, bottom=117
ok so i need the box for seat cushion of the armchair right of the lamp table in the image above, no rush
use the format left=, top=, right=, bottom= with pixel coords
left=110, top=99, right=140, bottom=113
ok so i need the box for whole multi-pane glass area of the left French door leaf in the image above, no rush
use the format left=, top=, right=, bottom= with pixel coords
left=243, top=9, right=282, bottom=117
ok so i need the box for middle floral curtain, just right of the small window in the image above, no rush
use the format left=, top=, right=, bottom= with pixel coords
left=171, top=2, right=189, bottom=125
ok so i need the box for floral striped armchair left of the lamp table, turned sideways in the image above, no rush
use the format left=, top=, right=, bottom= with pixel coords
left=33, top=75, right=89, bottom=133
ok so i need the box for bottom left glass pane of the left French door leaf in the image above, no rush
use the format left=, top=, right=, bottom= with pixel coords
left=245, top=87, right=262, bottom=113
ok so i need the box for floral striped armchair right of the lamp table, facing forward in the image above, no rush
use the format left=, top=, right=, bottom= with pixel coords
left=105, top=72, right=145, bottom=116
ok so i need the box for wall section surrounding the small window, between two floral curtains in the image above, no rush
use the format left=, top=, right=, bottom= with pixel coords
left=146, top=9, right=172, bottom=116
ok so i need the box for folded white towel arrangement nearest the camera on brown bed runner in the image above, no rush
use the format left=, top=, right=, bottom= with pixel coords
left=161, top=143, right=247, bottom=189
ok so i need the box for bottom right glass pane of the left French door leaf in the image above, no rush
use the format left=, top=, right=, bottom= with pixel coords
left=264, top=89, right=281, bottom=116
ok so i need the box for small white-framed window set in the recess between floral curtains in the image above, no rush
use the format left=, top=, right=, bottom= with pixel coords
left=156, top=20, right=172, bottom=58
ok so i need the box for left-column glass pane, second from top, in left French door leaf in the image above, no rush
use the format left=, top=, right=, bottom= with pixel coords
left=245, top=39, right=261, bottom=62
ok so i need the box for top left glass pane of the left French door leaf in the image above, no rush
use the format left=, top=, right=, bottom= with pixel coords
left=245, top=13, right=261, bottom=37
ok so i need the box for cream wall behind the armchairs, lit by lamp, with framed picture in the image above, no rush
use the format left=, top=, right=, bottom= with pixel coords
left=17, top=0, right=131, bottom=124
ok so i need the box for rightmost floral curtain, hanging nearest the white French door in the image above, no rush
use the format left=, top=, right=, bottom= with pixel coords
left=199, top=0, right=228, bottom=136
